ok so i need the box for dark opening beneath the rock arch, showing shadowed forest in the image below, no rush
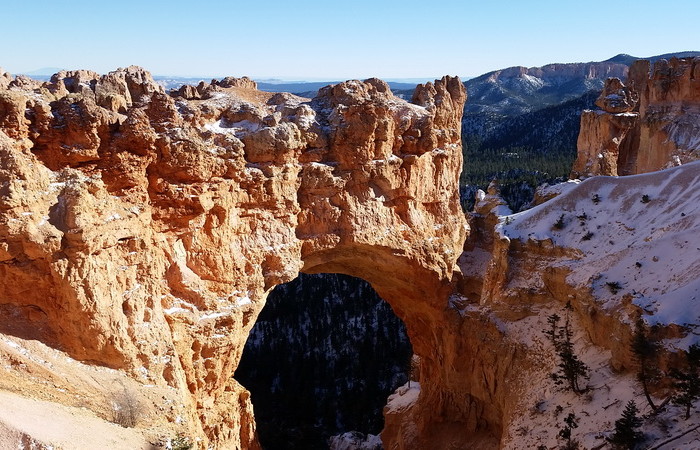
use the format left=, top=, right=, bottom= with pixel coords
left=235, top=273, right=413, bottom=449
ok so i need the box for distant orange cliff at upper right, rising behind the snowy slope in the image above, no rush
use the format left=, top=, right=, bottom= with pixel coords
left=572, top=57, right=700, bottom=177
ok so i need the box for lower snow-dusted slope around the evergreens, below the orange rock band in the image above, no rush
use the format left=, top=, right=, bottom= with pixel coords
left=501, top=309, right=700, bottom=450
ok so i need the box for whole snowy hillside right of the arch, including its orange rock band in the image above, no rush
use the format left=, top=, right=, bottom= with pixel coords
left=460, top=162, right=700, bottom=450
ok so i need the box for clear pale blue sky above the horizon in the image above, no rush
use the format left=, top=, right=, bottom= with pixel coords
left=0, top=0, right=700, bottom=80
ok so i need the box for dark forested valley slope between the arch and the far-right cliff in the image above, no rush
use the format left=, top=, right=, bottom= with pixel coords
left=460, top=91, right=599, bottom=212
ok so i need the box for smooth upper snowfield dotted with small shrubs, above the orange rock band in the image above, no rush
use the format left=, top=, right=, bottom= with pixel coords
left=499, top=162, right=700, bottom=347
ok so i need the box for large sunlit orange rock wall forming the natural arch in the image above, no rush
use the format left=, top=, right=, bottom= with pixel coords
left=0, top=67, right=470, bottom=448
